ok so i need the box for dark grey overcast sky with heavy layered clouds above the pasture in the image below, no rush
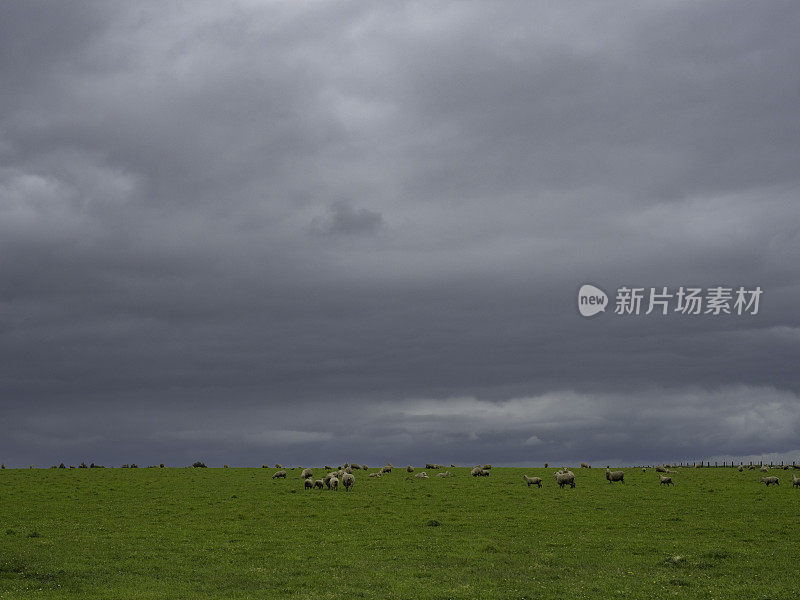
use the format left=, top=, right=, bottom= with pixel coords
left=0, top=0, right=800, bottom=466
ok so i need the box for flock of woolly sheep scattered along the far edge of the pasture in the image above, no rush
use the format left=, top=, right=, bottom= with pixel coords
left=272, top=463, right=800, bottom=491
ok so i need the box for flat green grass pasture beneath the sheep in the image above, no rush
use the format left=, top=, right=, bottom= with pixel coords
left=0, top=468, right=800, bottom=599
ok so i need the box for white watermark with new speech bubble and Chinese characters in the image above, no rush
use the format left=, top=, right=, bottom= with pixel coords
left=578, top=283, right=764, bottom=317
